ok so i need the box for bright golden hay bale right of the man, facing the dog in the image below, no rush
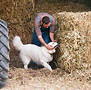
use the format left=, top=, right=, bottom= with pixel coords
left=54, top=12, right=91, bottom=72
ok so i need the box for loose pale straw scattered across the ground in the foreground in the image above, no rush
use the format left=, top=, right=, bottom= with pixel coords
left=3, top=68, right=91, bottom=90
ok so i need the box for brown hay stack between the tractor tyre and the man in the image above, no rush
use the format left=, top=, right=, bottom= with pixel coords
left=0, top=0, right=35, bottom=56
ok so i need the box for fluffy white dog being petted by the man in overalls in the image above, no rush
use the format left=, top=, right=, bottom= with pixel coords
left=13, top=36, right=58, bottom=71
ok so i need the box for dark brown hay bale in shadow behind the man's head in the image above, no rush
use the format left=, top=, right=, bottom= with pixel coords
left=35, top=0, right=91, bottom=15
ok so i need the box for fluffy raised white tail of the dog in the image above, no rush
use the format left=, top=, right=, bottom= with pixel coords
left=13, top=36, right=23, bottom=51
